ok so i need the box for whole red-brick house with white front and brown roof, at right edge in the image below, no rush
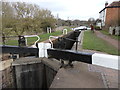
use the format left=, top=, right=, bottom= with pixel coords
left=99, top=1, right=120, bottom=29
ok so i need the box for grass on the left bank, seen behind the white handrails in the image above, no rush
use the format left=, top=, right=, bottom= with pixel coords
left=6, top=28, right=71, bottom=45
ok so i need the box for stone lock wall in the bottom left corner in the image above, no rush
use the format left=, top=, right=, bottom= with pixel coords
left=0, top=54, right=14, bottom=88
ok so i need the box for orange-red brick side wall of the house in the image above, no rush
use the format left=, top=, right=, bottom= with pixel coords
left=105, top=8, right=120, bottom=28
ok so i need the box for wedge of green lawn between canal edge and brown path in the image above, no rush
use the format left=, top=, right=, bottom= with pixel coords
left=82, top=31, right=118, bottom=55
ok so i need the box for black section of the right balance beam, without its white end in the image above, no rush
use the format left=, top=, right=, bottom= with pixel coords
left=47, top=49, right=94, bottom=64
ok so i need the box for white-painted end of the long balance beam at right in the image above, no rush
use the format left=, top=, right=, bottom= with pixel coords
left=92, top=53, right=120, bottom=70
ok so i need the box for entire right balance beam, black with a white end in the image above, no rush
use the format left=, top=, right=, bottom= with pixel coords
left=47, top=49, right=119, bottom=70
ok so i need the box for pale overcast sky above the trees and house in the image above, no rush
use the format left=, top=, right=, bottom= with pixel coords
left=3, top=0, right=119, bottom=20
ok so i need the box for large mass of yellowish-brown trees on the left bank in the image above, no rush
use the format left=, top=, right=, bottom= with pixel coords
left=2, top=2, right=55, bottom=35
